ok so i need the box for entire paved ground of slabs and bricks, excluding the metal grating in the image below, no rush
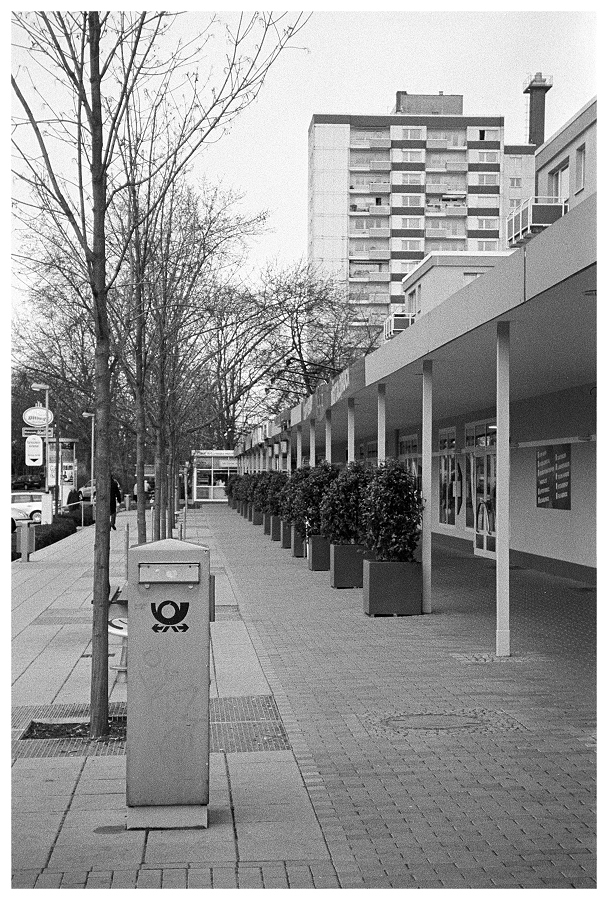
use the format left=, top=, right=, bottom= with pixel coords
left=13, top=506, right=595, bottom=888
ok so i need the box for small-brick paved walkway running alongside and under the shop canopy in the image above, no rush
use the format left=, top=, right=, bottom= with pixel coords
left=209, top=512, right=595, bottom=888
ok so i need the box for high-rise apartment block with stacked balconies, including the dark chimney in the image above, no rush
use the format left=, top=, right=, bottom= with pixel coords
left=308, top=73, right=550, bottom=322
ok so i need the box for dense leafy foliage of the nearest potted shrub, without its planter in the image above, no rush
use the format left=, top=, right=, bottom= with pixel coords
left=362, top=459, right=422, bottom=562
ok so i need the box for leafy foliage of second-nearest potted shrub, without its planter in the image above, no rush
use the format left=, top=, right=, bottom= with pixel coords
left=320, top=462, right=372, bottom=544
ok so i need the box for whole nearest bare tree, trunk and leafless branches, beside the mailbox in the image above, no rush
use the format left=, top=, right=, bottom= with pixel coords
left=11, top=12, right=304, bottom=737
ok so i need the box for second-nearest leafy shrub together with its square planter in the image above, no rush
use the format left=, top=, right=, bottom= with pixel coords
left=320, top=462, right=371, bottom=588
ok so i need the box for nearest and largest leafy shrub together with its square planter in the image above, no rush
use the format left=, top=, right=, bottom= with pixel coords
left=362, top=460, right=422, bottom=616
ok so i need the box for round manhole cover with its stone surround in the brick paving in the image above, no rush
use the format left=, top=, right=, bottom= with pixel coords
left=364, top=708, right=528, bottom=739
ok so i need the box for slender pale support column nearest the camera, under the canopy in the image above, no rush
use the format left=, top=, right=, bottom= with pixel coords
left=496, top=322, right=511, bottom=656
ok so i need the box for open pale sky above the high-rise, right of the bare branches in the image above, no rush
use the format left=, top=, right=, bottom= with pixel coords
left=180, top=5, right=596, bottom=276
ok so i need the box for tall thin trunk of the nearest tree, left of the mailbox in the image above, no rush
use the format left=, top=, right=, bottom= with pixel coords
left=87, top=12, right=110, bottom=738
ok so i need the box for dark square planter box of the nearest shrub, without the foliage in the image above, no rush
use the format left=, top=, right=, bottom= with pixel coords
left=363, top=559, right=422, bottom=616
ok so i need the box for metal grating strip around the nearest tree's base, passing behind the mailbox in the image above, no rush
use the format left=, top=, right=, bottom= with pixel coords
left=12, top=695, right=290, bottom=759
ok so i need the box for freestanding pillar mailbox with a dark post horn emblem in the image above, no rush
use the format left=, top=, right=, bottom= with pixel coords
left=127, top=539, right=210, bottom=828
